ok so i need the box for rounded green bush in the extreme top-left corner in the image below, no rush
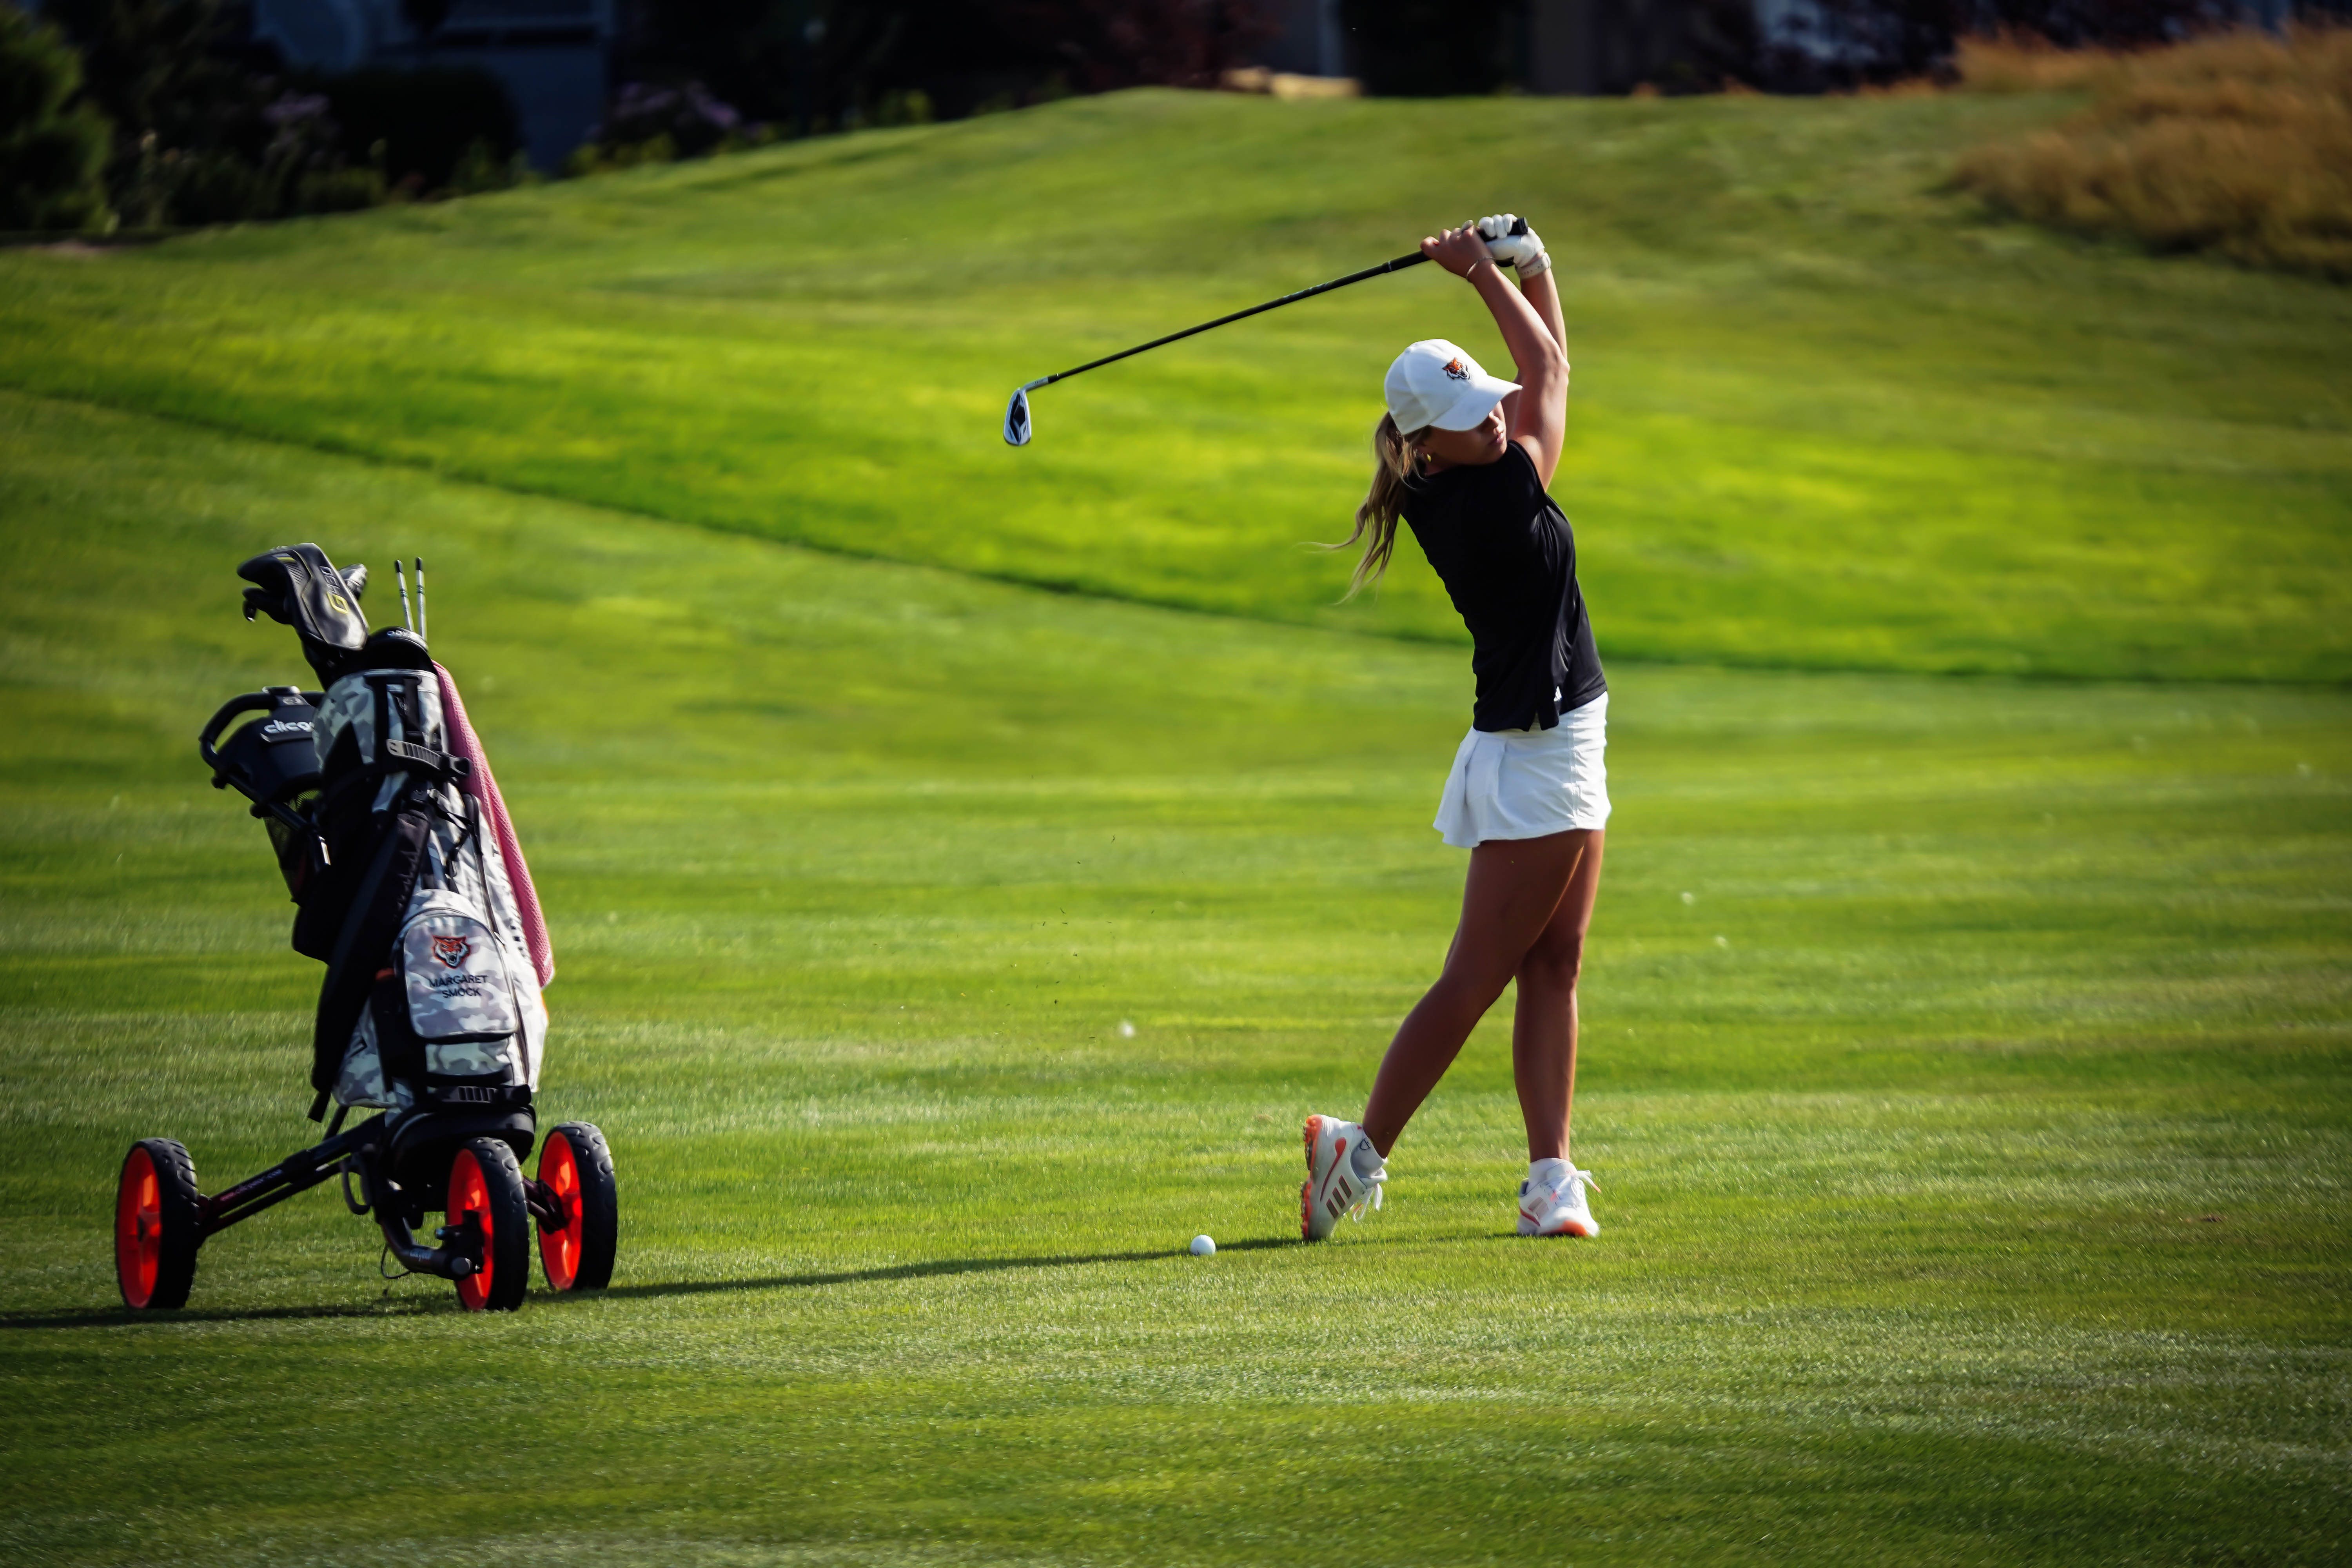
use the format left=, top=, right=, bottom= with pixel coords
left=0, top=0, right=113, bottom=228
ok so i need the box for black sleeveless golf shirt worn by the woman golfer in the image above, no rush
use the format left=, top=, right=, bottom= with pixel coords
left=1404, top=442, right=1609, bottom=731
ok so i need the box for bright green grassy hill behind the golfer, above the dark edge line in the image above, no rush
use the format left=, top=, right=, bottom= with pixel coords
left=0, top=92, right=2352, bottom=682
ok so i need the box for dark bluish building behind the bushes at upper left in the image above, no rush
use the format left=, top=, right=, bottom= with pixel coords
left=254, top=0, right=614, bottom=169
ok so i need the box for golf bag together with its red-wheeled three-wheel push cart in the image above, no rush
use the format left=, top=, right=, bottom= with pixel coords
left=115, top=545, right=619, bottom=1312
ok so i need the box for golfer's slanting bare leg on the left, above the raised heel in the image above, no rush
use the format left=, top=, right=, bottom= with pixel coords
left=1364, top=832, right=1595, bottom=1154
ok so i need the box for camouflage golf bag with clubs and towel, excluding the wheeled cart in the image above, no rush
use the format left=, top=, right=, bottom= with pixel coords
left=218, top=545, right=553, bottom=1133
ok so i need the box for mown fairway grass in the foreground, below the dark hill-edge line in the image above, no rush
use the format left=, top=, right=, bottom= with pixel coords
left=0, top=383, right=2352, bottom=1566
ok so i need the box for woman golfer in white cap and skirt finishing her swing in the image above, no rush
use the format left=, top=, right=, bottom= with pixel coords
left=1298, top=214, right=1609, bottom=1241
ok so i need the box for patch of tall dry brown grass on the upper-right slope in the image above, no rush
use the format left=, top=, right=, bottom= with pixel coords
left=1957, top=28, right=2352, bottom=278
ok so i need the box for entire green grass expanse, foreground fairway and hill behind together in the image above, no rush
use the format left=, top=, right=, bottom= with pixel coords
left=0, top=94, right=2352, bottom=1568
